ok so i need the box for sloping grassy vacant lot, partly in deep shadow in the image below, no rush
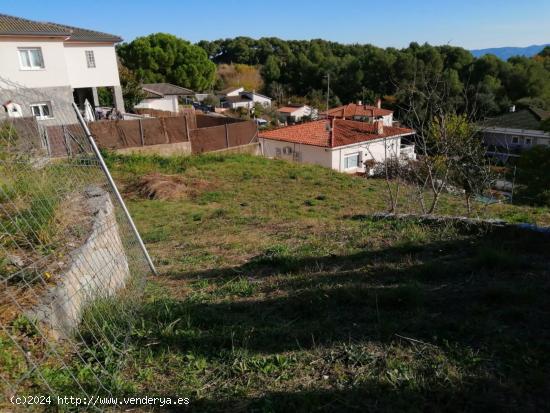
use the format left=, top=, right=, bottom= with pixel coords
left=104, top=155, right=550, bottom=412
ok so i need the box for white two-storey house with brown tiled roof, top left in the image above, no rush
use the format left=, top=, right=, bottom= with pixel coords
left=0, top=14, right=124, bottom=124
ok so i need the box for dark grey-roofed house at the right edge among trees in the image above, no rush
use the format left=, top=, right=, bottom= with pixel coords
left=480, top=106, right=550, bottom=161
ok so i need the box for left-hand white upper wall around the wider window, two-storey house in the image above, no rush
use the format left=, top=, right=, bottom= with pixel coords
left=0, top=38, right=70, bottom=88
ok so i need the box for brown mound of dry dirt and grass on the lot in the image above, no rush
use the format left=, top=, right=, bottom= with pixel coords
left=126, top=172, right=208, bottom=200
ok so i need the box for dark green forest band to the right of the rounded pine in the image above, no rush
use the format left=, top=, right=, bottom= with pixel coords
left=198, top=37, right=550, bottom=114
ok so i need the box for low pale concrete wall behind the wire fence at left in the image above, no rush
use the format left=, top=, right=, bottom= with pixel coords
left=29, top=188, right=130, bottom=338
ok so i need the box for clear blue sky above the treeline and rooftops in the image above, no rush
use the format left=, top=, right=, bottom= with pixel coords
left=0, top=0, right=550, bottom=49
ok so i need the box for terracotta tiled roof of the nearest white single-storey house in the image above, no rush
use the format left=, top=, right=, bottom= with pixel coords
left=260, top=119, right=414, bottom=148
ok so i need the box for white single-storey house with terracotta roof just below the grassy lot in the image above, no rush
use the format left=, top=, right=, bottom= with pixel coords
left=259, top=118, right=415, bottom=173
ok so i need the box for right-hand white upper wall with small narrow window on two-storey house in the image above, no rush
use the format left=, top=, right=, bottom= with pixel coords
left=64, top=42, right=120, bottom=88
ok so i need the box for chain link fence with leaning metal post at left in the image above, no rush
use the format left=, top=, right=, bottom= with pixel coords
left=0, top=77, right=154, bottom=411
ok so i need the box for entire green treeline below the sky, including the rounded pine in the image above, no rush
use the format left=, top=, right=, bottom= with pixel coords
left=118, top=33, right=550, bottom=116
